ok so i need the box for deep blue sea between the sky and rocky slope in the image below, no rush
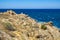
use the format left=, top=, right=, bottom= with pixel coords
left=0, top=9, right=60, bottom=28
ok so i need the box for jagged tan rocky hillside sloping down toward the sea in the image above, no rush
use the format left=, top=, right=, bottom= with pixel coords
left=0, top=10, right=60, bottom=40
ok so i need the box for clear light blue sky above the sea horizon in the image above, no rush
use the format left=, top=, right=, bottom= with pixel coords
left=0, top=0, right=60, bottom=9
